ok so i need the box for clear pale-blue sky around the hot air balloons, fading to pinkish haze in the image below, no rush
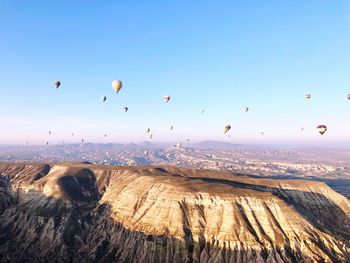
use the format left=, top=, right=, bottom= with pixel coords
left=0, top=0, right=350, bottom=146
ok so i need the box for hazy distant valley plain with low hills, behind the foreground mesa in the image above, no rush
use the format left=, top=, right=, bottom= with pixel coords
left=0, top=141, right=350, bottom=198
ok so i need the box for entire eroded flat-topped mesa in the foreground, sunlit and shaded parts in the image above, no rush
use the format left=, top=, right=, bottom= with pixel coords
left=0, top=163, right=350, bottom=262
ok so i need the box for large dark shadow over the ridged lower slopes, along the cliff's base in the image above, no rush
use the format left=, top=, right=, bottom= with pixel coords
left=0, top=188, right=324, bottom=263
